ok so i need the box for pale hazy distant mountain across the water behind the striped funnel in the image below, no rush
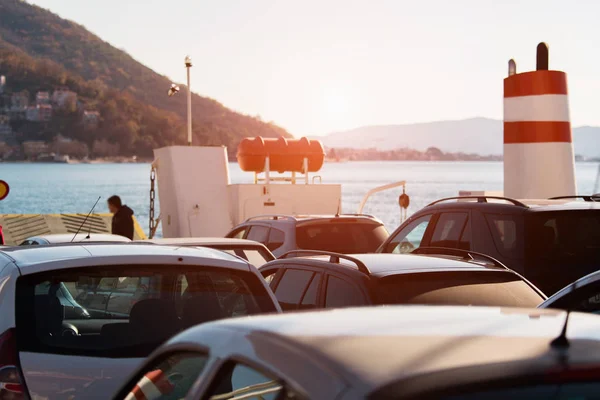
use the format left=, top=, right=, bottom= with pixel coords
left=318, top=118, right=600, bottom=158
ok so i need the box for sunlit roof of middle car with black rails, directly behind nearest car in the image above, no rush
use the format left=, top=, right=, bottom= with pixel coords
left=270, top=253, right=507, bottom=277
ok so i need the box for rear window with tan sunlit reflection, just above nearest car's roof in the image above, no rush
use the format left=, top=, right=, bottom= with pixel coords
left=376, top=271, right=544, bottom=307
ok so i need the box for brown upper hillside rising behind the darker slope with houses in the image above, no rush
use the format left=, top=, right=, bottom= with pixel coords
left=0, top=0, right=290, bottom=153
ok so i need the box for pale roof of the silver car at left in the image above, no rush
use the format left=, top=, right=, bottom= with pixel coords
left=0, top=243, right=249, bottom=274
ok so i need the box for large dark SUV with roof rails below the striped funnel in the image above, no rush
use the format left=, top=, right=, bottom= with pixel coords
left=378, top=196, right=600, bottom=295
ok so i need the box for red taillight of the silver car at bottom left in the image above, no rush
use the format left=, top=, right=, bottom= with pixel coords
left=0, top=329, right=25, bottom=400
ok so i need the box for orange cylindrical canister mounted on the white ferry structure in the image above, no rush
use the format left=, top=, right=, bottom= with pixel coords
left=237, top=137, right=325, bottom=173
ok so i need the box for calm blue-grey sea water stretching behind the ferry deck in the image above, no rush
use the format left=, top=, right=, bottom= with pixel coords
left=0, top=162, right=598, bottom=238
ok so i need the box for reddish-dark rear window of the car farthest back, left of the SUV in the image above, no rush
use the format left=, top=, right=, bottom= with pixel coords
left=296, top=218, right=389, bottom=254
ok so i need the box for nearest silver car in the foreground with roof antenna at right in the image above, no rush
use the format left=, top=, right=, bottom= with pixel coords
left=114, top=306, right=600, bottom=400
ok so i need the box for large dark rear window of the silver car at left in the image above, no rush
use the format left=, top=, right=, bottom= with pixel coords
left=16, top=265, right=276, bottom=357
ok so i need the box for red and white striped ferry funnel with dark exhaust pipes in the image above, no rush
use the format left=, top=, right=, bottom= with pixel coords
left=504, top=43, right=576, bottom=199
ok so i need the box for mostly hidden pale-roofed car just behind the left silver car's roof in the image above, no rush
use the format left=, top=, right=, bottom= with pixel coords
left=136, top=237, right=275, bottom=268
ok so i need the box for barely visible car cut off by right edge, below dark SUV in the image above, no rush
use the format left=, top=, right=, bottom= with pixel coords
left=539, top=271, right=600, bottom=314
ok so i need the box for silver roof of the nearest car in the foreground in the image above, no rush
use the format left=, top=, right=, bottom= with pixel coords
left=169, top=306, right=600, bottom=390
